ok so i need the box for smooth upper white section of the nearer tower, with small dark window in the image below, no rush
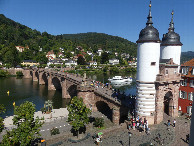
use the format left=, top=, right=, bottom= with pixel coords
left=137, top=42, right=160, bottom=82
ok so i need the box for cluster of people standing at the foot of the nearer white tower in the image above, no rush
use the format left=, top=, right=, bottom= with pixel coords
left=128, top=115, right=150, bottom=134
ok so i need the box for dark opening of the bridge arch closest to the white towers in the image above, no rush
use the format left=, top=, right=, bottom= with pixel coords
left=96, top=101, right=113, bottom=121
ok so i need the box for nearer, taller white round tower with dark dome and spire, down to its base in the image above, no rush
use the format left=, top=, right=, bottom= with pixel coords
left=136, top=1, right=160, bottom=124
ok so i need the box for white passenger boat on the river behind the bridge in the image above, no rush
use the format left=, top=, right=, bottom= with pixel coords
left=108, top=76, right=132, bottom=84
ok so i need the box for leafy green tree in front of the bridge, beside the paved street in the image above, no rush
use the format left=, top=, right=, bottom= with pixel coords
left=67, top=96, right=91, bottom=136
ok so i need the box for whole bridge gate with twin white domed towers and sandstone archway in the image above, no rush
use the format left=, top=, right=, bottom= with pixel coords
left=135, top=2, right=182, bottom=124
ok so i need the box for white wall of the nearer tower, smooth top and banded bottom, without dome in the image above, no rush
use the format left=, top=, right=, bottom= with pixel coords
left=136, top=42, right=160, bottom=116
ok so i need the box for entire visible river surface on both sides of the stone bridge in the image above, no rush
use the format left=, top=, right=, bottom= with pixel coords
left=0, top=74, right=136, bottom=117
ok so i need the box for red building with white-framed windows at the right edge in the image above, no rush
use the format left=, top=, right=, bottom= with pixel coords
left=178, top=58, right=194, bottom=115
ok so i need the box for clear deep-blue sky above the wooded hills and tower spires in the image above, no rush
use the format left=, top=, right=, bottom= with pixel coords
left=0, top=0, right=194, bottom=52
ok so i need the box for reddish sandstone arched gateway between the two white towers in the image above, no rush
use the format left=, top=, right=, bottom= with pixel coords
left=154, top=59, right=181, bottom=124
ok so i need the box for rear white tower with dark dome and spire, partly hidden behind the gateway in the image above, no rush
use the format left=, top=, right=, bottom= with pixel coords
left=160, top=11, right=182, bottom=65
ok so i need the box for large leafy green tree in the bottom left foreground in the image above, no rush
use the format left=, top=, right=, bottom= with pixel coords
left=2, top=101, right=43, bottom=146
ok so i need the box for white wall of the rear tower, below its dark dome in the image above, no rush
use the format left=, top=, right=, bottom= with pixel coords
left=160, top=46, right=181, bottom=66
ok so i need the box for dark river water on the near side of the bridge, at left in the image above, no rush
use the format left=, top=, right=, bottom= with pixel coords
left=0, top=77, right=63, bottom=117
